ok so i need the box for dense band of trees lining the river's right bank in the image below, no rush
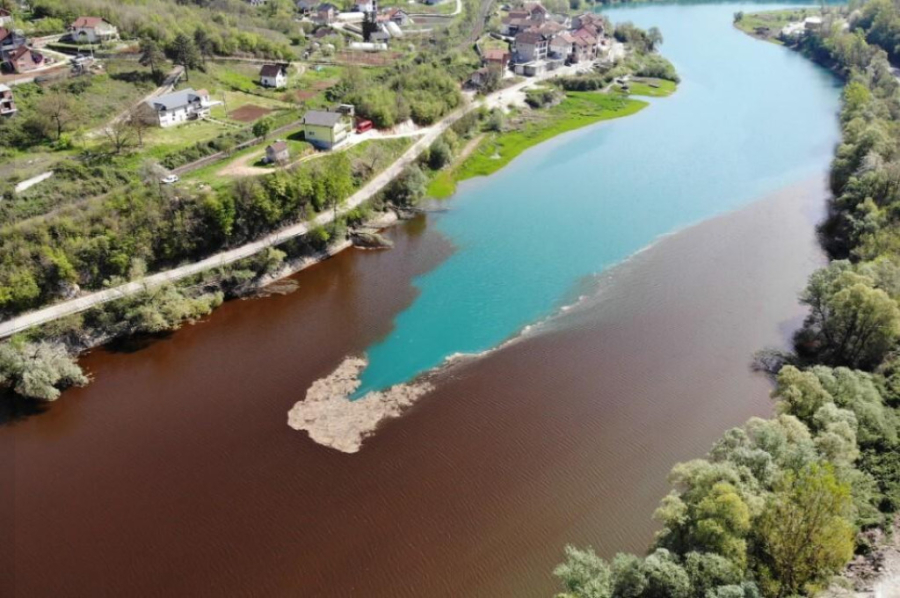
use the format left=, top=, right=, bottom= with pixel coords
left=556, top=0, right=900, bottom=598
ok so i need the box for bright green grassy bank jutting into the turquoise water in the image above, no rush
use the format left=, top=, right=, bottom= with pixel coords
left=428, top=91, right=648, bottom=199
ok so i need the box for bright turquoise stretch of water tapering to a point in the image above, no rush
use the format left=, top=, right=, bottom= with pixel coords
left=357, top=4, right=840, bottom=396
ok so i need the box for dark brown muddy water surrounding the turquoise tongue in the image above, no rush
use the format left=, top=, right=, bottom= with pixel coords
left=0, top=181, right=825, bottom=598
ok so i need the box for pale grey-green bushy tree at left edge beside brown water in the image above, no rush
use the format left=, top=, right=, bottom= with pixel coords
left=0, top=339, right=88, bottom=401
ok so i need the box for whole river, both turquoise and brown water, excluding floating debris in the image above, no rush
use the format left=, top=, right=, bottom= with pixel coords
left=0, top=4, right=839, bottom=598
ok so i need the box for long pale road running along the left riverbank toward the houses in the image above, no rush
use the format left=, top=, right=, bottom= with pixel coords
left=0, top=67, right=572, bottom=338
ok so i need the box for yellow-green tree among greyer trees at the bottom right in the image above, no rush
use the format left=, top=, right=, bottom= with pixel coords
left=759, top=464, right=854, bottom=598
